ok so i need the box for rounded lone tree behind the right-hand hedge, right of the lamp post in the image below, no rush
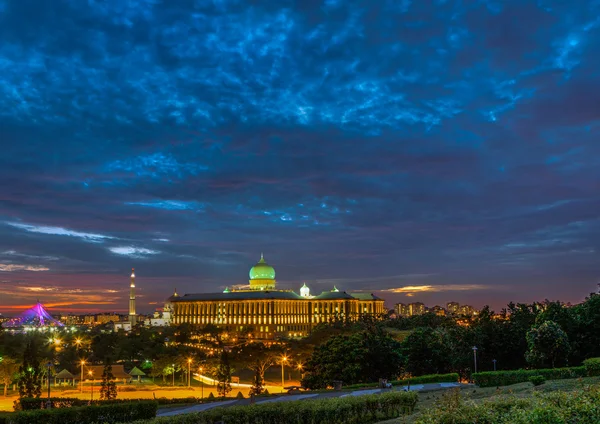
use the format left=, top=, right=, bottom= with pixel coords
left=525, top=321, right=569, bottom=368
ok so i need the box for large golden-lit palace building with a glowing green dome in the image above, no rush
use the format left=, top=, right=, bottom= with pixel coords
left=165, top=255, right=384, bottom=339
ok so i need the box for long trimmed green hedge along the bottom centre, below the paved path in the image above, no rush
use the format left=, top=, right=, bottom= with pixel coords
left=135, top=392, right=417, bottom=424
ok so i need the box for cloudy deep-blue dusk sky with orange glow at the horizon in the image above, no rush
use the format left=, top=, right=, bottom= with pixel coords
left=0, top=0, right=600, bottom=315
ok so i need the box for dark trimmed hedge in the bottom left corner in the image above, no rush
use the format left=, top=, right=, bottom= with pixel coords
left=5, top=401, right=158, bottom=424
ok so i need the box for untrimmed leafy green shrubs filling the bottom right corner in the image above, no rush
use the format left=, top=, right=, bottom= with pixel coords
left=415, top=387, right=600, bottom=424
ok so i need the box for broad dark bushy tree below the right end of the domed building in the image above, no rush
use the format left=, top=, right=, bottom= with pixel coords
left=302, top=329, right=402, bottom=389
